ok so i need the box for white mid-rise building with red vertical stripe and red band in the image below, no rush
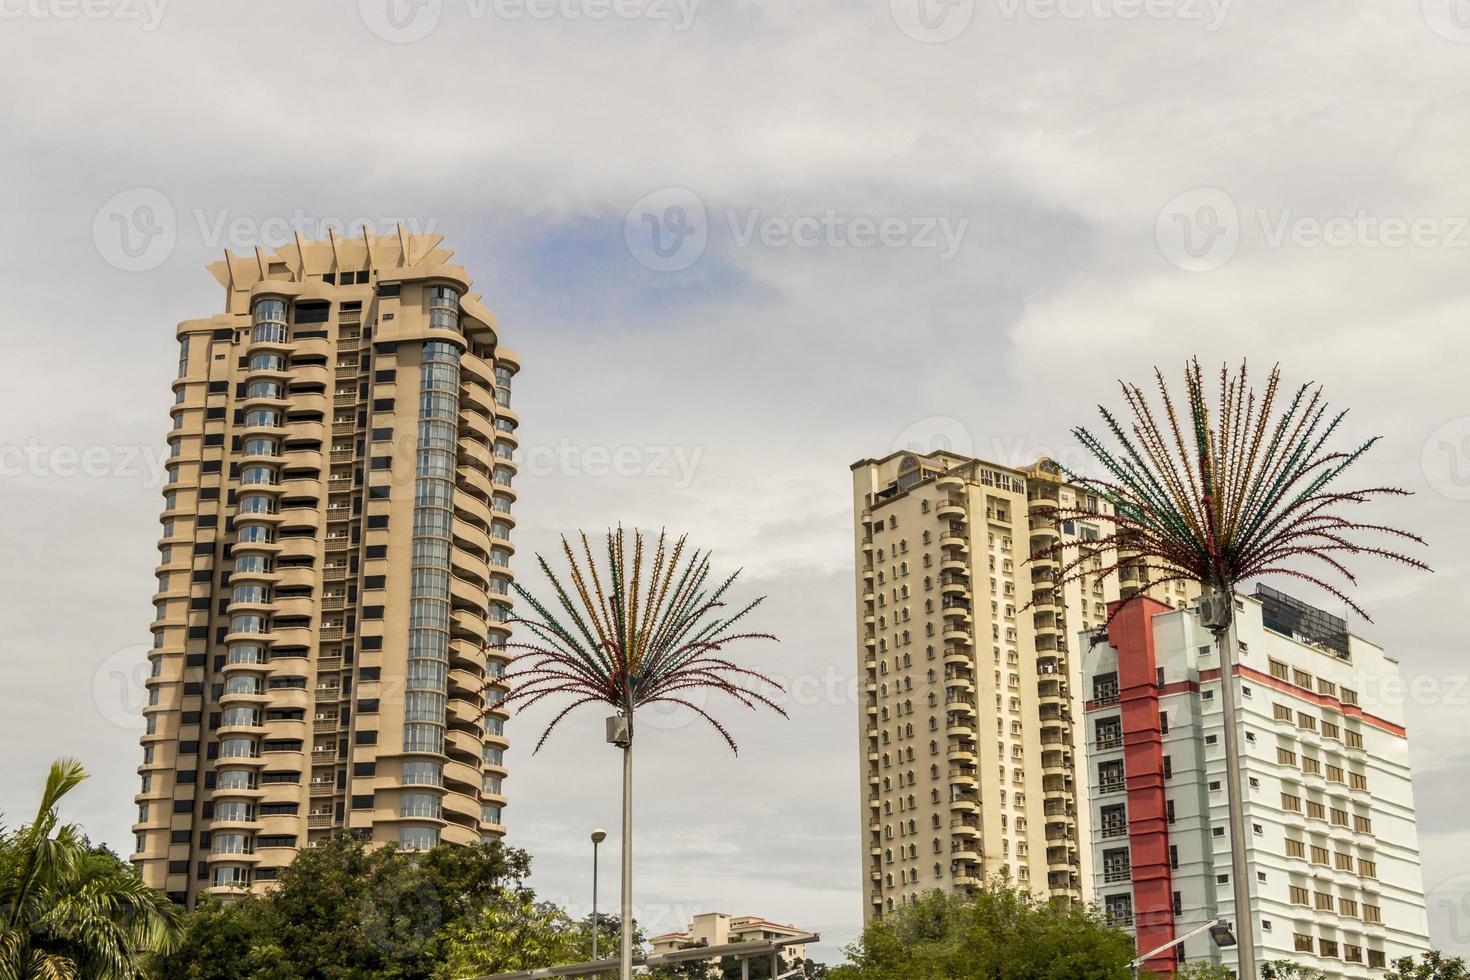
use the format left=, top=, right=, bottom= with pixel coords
left=1082, top=588, right=1429, bottom=977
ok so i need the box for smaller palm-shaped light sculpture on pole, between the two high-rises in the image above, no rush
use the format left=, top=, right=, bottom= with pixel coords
left=506, top=527, right=786, bottom=980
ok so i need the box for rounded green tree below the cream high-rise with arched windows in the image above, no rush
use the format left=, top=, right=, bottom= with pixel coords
left=831, top=876, right=1135, bottom=980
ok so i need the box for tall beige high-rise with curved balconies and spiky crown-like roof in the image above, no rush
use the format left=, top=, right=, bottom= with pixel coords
left=132, top=228, right=519, bottom=904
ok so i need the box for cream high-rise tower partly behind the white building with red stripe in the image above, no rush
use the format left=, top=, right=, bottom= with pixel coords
left=853, top=451, right=1188, bottom=918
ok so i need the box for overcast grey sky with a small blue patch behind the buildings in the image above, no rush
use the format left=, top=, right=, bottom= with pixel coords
left=0, top=0, right=1470, bottom=959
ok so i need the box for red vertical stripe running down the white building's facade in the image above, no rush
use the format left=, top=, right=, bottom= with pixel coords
left=1108, top=598, right=1175, bottom=976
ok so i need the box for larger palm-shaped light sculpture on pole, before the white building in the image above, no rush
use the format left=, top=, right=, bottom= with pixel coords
left=1047, top=360, right=1427, bottom=979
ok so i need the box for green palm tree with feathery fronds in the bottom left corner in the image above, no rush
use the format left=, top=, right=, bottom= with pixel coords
left=0, top=760, right=181, bottom=980
